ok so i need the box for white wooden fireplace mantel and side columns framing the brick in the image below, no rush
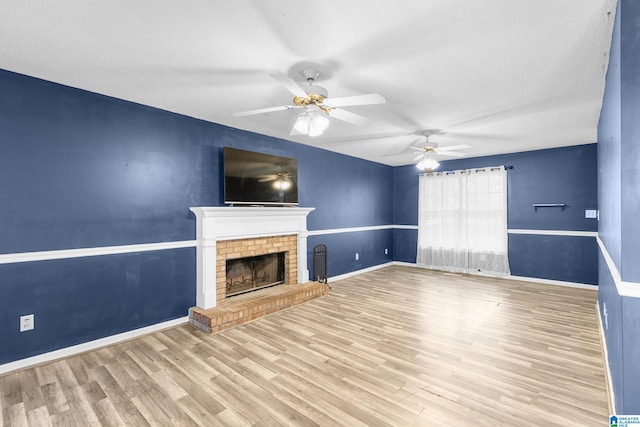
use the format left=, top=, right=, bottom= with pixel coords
left=191, top=206, right=315, bottom=309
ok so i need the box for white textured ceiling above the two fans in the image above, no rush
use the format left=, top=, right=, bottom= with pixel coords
left=0, top=0, right=616, bottom=165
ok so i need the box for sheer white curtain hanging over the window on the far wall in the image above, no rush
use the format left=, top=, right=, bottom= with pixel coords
left=417, top=166, right=510, bottom=275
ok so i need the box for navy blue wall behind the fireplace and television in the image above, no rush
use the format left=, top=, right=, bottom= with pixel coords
left=0, top=70, right=393, bottom=364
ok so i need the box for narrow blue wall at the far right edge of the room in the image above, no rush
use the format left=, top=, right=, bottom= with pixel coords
left=598, top=0, right=640, bottom=414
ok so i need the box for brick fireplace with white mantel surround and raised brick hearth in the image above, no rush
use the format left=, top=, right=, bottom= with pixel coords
left=189, top=207, right=328, bottom=333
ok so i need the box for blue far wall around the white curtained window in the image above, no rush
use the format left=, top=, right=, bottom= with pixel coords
left=393, top=144, right=598, bottom=284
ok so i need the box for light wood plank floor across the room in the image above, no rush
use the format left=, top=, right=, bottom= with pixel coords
left=0, top=266, right=608, bottom=426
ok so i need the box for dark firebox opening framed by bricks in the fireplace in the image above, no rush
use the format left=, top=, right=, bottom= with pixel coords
left=226, top=252, right=285, bottom=297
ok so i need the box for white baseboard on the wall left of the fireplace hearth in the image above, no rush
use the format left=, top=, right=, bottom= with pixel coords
left=0, top=317, right=189, bottom=375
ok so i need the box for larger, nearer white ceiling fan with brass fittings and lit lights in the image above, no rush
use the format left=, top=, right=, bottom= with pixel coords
left=233, top=67, right=386, bottom=136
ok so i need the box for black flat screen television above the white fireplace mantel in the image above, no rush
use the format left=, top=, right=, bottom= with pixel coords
left=223, top=147, right=298, bottom=206
